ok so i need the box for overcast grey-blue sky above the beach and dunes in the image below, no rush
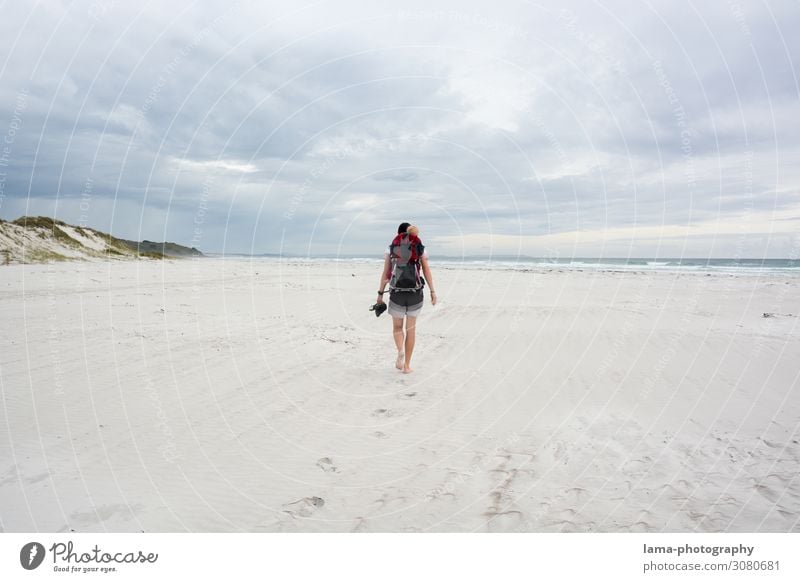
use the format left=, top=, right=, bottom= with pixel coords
left=0, top=0, right=800, bottom=257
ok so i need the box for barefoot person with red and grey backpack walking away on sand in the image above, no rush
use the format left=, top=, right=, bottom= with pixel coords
left=377, top=222, right=436, bottom=374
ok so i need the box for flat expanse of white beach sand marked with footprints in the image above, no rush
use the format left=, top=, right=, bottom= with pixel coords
left=0, top=259, right=800, bottom=532
